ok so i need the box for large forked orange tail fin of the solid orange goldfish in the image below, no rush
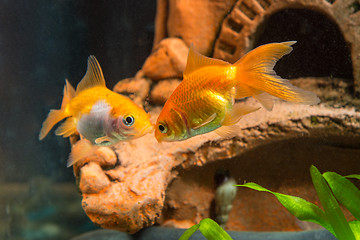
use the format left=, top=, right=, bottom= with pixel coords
left=234, top=41, right=320, bottom=109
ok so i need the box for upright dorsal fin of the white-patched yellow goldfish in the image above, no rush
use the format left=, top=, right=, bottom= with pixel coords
left=76, top=55, right=105, bottom=94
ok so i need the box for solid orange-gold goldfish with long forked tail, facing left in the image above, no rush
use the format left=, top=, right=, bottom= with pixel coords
left=155, top=41, right=320, bottom=142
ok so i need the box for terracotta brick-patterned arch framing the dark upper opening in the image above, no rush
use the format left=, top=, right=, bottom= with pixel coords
left=213, top=0, right=360, bottom=92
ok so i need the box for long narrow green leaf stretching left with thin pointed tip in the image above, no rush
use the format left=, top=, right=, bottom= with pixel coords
left=236, top=182, right=335, bottom=235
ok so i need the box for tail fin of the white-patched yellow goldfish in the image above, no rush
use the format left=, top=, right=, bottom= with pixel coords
left=39, top=79, right=75, bottom=140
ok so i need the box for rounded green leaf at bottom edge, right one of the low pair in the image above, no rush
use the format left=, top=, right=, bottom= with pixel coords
left=199, top=218, right=232, bottom=240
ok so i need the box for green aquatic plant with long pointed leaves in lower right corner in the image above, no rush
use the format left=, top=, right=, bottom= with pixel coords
left=236, top=166, right=360, bottom=240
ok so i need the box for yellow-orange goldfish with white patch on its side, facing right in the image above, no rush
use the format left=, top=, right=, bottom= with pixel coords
left=39, top=56, right=153, bottom=166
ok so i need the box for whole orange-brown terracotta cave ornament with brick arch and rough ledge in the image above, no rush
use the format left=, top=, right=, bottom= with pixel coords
left=74, top=0, right=360, bottom=233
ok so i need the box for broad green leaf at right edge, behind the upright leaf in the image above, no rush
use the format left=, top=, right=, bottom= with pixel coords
left=323, top=172, right=360, bottom=220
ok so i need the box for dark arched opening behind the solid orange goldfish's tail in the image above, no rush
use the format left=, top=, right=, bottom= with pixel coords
left=253, top=8, right=353, bottom=81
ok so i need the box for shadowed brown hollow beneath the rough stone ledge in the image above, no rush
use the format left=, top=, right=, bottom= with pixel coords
left=162, top=135, right=360, bottom=231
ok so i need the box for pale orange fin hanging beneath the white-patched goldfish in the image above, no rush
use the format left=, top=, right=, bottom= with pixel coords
left=67, top=138, right=99, bottom=167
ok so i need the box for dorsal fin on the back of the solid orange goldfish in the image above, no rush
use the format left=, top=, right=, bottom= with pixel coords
left=184, top=44, right=231, bottom=77
